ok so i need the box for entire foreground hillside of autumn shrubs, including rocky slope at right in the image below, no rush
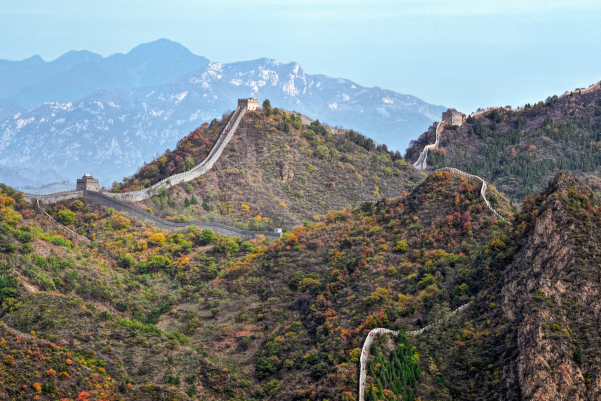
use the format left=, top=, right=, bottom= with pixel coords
left=0, top=152, right=601, bottom=401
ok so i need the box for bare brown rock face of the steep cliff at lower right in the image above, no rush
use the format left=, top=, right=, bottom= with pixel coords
left=501, top=173, right=601, bottom=400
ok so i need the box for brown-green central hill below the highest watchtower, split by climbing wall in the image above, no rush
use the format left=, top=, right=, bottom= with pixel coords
left=114, top=103, right=423, bottom=229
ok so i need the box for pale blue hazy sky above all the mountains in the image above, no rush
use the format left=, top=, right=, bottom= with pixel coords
left=0, top=0, right=601, bottom=112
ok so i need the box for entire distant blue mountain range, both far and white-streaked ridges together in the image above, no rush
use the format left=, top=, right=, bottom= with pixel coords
left=0, top=39, right=443, bottom=187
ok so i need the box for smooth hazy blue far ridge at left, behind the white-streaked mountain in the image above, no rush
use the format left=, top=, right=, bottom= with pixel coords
left=0, top=39, right=209, bottom=108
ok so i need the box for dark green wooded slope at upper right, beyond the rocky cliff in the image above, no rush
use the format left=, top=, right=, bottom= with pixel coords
left=406, top=85, right=601, bottom=199
